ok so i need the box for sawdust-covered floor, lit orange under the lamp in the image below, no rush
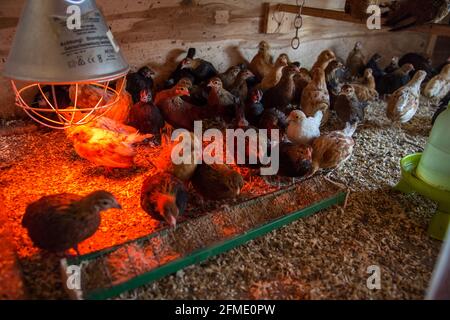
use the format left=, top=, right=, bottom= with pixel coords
left=0, top=100, right=441, bottom=299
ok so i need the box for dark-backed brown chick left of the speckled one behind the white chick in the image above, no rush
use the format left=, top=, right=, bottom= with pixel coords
left=263, top=65, right=299, bottom=113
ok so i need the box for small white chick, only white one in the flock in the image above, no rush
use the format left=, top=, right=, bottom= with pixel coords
left=286, top=110, right=323, bottom=145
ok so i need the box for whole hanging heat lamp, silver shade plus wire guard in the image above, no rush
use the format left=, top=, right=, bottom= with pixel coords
left=4, top=0, right=129, bottom=129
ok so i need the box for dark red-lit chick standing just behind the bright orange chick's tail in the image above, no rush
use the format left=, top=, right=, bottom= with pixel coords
left=128, top=90, right=164, bottom=135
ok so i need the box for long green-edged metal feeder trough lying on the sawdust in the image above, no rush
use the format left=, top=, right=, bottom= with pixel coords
left=61, top=177, right=346, bottom=299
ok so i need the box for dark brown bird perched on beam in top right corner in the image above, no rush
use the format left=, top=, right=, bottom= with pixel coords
left=385, top=0, right=450, bottom=31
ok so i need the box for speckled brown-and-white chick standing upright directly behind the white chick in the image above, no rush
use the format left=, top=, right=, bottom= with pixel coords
left=300, top=68, right=330, bottom=125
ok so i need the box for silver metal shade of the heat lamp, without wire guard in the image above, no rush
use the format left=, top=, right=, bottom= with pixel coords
left=4, top=0, right=129, bottom=84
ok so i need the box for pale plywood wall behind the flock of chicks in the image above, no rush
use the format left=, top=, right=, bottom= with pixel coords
left=0, top=0, right=428, bottom=118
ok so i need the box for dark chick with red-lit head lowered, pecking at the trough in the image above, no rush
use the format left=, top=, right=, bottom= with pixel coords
left=141, top=172, right=189, bottom=227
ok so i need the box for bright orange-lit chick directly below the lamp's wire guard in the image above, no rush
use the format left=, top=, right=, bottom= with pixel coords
left=67, top=118, right=152, bottom=168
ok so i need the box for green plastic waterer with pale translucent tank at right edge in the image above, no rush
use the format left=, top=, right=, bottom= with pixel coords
left=395, top=109, right=450, bottom=240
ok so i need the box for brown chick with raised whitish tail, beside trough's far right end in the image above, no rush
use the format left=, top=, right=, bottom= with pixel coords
left=312, top=123, right=357, bottom=174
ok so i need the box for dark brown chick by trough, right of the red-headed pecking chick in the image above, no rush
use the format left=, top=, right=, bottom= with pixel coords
left=192, top=164, right=244, bottom=200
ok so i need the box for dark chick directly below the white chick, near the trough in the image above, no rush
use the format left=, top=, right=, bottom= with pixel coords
left=279, top=142, right=312, bottom=178
